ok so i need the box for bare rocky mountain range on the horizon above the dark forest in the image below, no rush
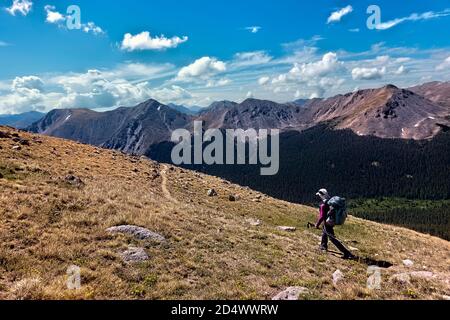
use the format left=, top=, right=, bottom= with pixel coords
left=29, top=82, right=450, bottom=144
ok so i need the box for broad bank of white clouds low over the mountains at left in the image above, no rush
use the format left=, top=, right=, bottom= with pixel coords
left=0, top=64, right=193, bottom=113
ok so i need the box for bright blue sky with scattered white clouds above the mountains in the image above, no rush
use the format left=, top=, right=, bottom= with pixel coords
left=0, top=0, right=450, bottom=113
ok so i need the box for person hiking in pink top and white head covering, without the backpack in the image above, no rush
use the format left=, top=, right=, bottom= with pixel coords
left=316, top=189, right=355, bottom=259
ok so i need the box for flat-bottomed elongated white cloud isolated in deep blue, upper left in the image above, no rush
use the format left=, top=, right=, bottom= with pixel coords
left=121, top=31, right=189, bottom=52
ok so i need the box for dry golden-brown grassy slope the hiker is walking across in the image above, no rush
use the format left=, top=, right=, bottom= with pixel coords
left=0, top=127, right=450, bottom=299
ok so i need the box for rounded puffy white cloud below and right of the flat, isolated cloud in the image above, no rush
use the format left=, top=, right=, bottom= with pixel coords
left=176, top=57, right=227, bottom=81
